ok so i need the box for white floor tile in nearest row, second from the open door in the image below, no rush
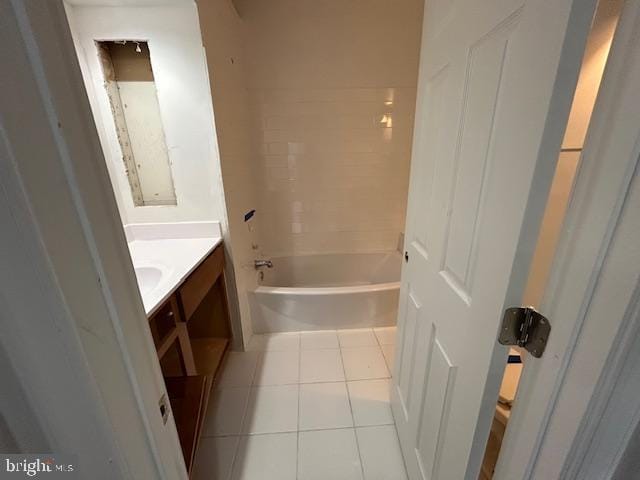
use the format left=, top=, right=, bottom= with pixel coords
left=298, top=428, right=362, bottom=480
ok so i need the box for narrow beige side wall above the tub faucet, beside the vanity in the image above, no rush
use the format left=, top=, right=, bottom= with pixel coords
left=198, top=0, right=262, bottom=341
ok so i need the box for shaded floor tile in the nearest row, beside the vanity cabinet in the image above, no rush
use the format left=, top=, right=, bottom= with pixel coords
left=191, top=437, right=240, bottom=480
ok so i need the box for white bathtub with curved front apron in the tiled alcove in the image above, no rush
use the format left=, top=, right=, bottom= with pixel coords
left=249, top=252, right=401, bottom=333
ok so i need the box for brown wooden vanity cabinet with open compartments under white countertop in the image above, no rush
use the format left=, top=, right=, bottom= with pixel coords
left=149, top=244, right=231, bottom=474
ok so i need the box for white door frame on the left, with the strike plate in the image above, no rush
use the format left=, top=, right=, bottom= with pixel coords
left=0, top=0, right=187, bottom=480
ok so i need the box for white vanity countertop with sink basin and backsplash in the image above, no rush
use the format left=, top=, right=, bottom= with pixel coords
left=125, top=222, right=222, bottom=316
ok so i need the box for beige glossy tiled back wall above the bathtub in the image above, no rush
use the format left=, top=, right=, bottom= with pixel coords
left=242, top=0, right=422, bottom=256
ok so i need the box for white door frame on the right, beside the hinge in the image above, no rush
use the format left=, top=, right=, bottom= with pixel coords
left=494, top=2, right=640, bottom=480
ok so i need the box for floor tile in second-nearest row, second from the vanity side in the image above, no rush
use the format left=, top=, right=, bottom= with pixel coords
left=242, top=385, right=298, bottom=433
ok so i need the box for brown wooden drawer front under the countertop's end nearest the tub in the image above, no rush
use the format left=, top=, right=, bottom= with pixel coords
left=178, top=245, right=224, bottom=321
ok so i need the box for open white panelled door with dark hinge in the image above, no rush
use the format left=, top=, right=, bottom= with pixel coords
left=392, top=0, right=595, bottom=480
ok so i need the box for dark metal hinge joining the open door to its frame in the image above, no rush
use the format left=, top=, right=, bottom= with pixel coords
left=498, top=307, right=551, bottom=358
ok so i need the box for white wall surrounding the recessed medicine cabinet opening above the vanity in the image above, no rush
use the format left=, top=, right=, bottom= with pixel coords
left=67, top=2, right=225, bottom=223
